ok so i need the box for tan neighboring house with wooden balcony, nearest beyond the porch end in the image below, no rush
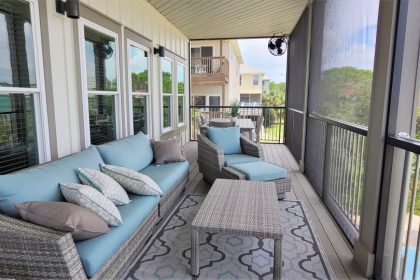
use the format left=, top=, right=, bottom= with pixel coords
left=191, top=40, right=243, bottom=106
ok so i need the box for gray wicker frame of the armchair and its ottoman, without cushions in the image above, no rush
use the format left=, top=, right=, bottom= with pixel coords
left=197, top=134, right=291, bottom=199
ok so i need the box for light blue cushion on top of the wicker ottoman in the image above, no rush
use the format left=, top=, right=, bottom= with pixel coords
left=231, top=161, right=287, bottom=181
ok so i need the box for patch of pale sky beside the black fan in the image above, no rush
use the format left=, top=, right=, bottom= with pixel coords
left=238, top=38, right=287, bottom=83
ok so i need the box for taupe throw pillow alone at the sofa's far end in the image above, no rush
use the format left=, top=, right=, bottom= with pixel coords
left=153, top=139, right=185, bottom=164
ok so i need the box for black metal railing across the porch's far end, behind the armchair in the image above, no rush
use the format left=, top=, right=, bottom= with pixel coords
left=190, top=106, right=286, bottom=144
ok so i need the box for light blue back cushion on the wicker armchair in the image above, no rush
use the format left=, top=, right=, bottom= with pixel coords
left=207, top=126, right=242, bottom=155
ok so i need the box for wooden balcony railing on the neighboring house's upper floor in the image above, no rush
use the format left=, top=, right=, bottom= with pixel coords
left=191, top=56, right=229, bottom=76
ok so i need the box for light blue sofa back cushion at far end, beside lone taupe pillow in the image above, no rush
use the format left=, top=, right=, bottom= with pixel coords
left=97, top=132, right=153, bottom=171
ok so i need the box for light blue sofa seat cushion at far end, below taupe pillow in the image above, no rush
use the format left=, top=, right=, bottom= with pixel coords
left=140, top=161, right=189, bottom=194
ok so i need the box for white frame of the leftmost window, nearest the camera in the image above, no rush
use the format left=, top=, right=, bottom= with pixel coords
left=0, top=0, right=51, bottom=163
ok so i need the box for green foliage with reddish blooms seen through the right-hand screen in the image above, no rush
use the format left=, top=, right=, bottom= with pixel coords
left=318, top=67, right=373, bottom=126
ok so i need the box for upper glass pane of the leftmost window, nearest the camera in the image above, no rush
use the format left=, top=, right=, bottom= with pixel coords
left=0, top=0, right=36, bottom=88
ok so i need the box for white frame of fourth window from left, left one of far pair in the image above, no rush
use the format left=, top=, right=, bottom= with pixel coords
left=159, top=56, right=177, bottom=134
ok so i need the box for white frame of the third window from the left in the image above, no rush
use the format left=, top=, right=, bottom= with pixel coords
left=127, top=39, right=153, bottom=138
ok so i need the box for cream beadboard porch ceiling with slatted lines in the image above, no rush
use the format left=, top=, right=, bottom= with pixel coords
left=148, top=0, right=309, bottom=40
